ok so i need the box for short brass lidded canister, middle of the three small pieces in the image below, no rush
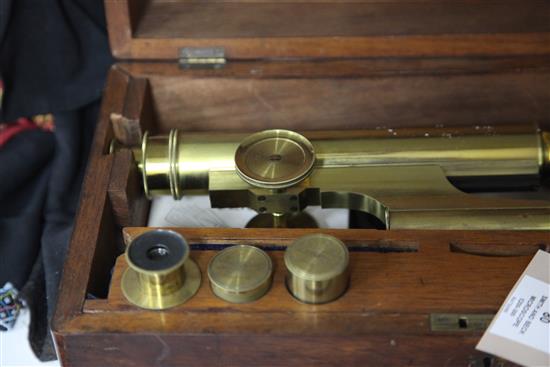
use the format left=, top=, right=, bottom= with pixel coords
left=208, top=245, right=273, bottom=303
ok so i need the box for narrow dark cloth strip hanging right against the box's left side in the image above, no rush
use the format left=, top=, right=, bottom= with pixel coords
left=27, top=102, right=99, bottom=360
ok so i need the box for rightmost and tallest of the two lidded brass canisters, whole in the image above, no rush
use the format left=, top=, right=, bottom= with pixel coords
left=285, top=234, right=349, bottom=304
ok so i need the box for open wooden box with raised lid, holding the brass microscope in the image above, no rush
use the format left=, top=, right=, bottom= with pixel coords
left=52, top=0, right=550, bottom=366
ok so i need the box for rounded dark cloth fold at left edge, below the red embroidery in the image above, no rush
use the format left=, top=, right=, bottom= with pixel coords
left=0, top=130, right=54, bottom=290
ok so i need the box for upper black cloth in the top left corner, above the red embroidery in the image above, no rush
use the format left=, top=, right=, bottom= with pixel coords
left=0, top=0, right=112, bottom=121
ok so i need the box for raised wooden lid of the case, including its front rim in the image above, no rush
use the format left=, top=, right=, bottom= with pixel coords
left=105, top=0, right=550, bottom=60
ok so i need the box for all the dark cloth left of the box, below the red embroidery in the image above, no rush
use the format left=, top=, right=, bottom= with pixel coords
left=0, top=102, right=99, bottom=360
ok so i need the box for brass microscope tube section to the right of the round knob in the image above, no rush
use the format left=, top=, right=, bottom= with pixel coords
left=313, top=134, right=542, bottom=177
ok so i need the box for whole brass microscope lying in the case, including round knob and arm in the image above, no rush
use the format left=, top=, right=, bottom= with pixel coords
left=117, top=126, right=550, bottom=230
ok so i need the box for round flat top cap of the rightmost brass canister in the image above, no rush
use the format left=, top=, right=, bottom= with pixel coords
left=285, top=234, right=349, bottom=281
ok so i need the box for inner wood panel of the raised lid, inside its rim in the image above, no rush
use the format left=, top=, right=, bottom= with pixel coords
left=134, top=0, right=550, bottom=39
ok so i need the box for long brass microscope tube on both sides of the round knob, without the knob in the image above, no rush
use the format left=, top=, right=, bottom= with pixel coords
left=134, top=130, right=550, bottom=199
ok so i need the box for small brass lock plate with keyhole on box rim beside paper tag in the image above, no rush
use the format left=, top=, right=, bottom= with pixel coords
left=430, top=313, right=495, bottom=332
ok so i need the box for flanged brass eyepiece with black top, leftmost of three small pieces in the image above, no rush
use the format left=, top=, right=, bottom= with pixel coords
left=121, top=230, right=201, bottom=310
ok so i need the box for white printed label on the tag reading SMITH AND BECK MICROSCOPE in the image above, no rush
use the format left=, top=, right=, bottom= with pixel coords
left=489, top=275, right=550, bottom=353
